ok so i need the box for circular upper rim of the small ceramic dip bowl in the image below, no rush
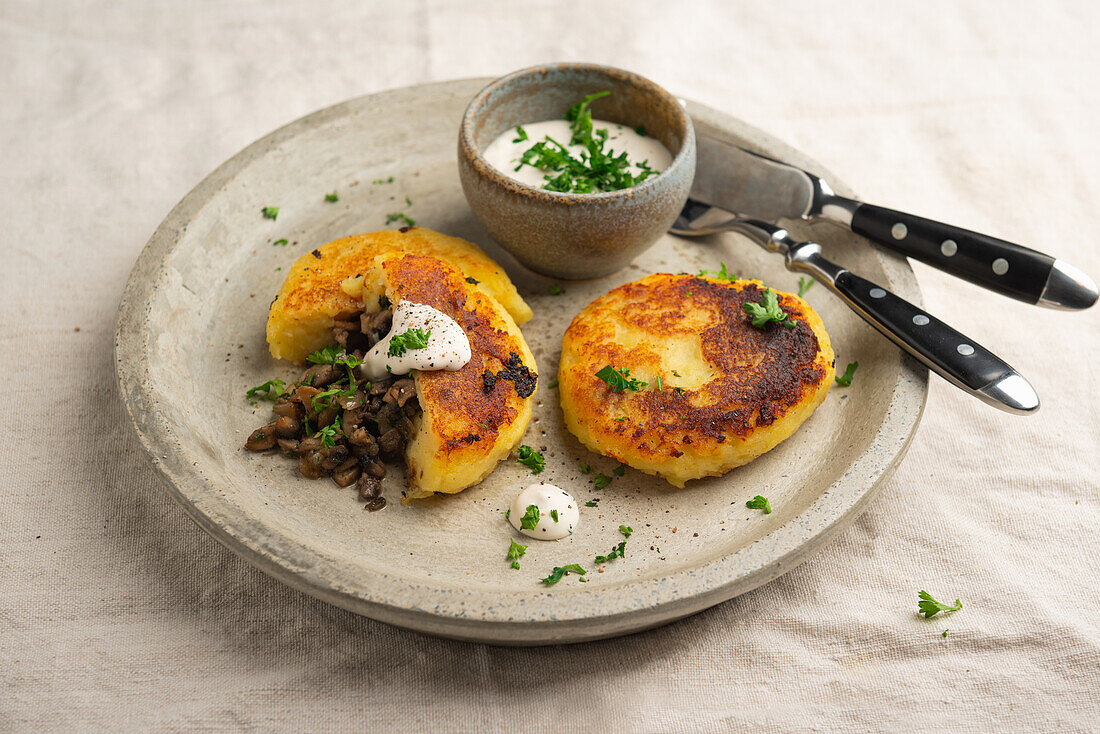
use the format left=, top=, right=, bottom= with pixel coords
left=459, top=62, right=695, bottom=205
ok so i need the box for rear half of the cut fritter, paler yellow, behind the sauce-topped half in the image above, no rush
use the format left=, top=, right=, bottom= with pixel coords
left=267, top=227, right=531, bottom=362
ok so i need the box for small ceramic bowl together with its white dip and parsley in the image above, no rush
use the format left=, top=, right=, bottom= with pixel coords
left=459, top=64, right=695, bottom=280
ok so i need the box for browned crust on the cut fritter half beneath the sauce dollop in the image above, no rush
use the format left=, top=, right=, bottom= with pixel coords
left=380, top=253, right=535, bottom=462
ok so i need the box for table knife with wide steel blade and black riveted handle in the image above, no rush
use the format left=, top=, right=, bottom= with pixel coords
left=691, top=135, right=1100, bottom=310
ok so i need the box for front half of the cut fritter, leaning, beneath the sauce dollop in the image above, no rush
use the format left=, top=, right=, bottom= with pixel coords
left=363, top=252, right=538, bottom=499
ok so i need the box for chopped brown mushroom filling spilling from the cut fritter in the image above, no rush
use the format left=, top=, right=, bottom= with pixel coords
left=244, top=308, right=420, bottom=512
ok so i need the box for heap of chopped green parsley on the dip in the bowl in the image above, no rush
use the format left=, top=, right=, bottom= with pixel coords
left=514, top=91, right=658, bottom=194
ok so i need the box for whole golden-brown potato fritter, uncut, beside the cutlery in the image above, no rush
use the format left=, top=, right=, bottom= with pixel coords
left=558, top=274, right=835, bottom=486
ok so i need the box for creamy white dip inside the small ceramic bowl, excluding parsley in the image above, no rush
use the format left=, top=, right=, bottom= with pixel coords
left=485, top=120, right=672, bottom=188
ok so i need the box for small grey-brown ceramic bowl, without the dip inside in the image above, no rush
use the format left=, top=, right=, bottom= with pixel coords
left=459, top=64, right=695, bottom=280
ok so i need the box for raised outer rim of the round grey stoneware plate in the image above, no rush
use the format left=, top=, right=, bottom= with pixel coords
left=114, top=77, right=928, bottom=645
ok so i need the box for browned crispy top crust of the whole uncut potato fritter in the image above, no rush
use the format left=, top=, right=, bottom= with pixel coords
left=561, top=274, right=832, bottom=468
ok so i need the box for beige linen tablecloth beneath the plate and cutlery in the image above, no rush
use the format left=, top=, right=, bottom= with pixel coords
left=0, top=0, right=1100, bottom=732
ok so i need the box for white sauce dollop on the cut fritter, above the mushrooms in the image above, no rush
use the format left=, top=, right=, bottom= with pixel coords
left=362, top=300, right=472, bottom=380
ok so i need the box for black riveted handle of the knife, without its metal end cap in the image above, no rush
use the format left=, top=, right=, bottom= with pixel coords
left=851, top=204, right=1055, bottom=304
